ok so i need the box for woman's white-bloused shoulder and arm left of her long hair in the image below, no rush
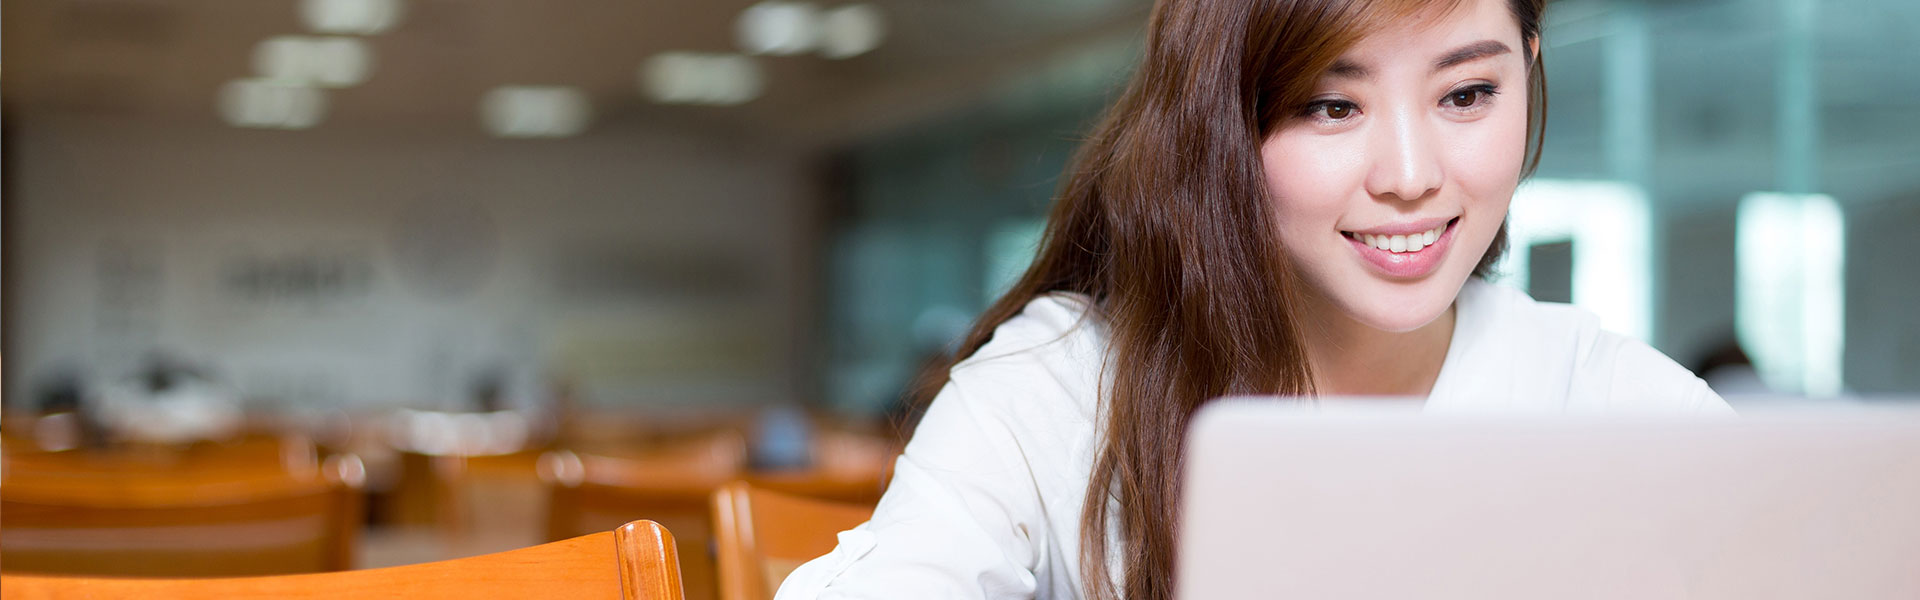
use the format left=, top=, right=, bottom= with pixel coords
left=780, top=294, right=1104, bottom=598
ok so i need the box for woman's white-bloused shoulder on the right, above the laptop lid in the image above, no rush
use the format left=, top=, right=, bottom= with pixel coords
left=1457, top=279, right=1726, bottom=412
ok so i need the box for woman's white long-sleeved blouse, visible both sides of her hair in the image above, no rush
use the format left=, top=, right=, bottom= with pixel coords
left=776, top=279, right=1730, bottom=600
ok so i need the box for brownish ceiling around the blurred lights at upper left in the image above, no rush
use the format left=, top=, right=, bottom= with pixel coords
left=4, top=0, right=1146, bottom=140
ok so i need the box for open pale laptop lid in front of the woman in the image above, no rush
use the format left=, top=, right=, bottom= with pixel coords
left=1177, top=398, right=1920, bottom=600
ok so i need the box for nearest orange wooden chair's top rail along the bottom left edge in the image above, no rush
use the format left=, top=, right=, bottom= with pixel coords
left=0, top=521, right=682, bottom=600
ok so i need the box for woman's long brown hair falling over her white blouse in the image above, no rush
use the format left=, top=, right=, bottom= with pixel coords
left=918, top=0, right=1546, bottom=600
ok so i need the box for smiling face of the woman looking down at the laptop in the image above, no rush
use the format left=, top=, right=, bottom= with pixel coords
left=1260, top=0, right=1532, bottom=331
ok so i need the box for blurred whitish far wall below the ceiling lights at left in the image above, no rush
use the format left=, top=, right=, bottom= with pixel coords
left=6, top=113, right=810, bottom=408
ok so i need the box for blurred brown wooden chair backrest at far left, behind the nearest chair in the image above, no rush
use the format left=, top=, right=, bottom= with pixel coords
left=0, top=454, right=365, bottom=577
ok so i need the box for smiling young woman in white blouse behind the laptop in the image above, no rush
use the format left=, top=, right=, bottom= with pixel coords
left=778, top=0, right=1726, bottom=600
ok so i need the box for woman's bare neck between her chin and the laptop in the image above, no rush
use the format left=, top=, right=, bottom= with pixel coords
left=1302, top=294, right=1455, bottom=398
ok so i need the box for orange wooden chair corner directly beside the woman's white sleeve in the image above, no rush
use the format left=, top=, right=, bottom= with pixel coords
left=712, top=481, right=874, bottom=600
